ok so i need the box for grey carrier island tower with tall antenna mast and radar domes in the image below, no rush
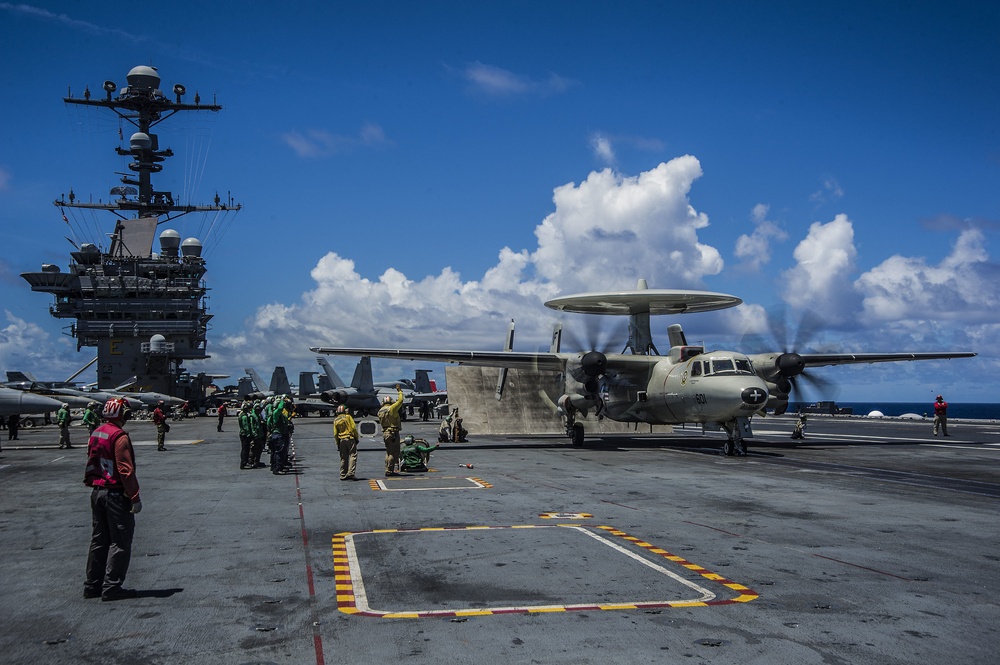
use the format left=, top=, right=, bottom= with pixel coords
left=21, top=66, right=241, bottom=400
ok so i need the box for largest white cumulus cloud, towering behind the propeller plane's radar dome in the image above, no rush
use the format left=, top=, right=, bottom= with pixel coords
left=219, top=156, right=723, bottom=362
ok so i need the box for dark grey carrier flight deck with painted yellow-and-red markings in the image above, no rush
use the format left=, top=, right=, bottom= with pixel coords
left=0, top=416, right=1000, bottom=665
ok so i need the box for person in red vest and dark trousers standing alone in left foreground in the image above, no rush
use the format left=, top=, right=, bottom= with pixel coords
left=83, top=397, right=142, bottom=600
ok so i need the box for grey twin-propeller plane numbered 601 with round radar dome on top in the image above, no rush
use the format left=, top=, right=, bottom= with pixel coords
left=310, top=279, right=976, bottom=455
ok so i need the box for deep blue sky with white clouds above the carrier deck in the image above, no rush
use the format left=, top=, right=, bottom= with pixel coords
left=0, top=1, right=1000, bottom=401
